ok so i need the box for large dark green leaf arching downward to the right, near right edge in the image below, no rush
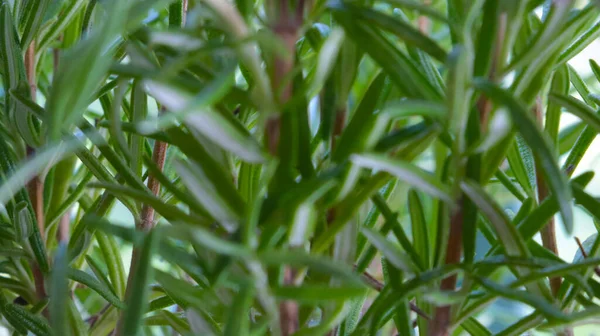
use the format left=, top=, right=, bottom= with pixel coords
left=475, top=80, right=573, bottom=233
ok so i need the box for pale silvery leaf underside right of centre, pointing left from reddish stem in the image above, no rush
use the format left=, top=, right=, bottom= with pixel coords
left=350, top=154, right=453, bottom=204
